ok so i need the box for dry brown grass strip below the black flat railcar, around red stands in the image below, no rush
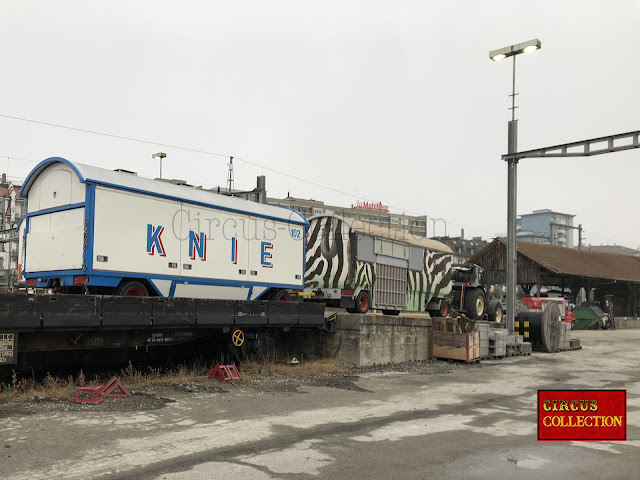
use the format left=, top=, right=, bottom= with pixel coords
left=0, top=354, right=350, bottom=402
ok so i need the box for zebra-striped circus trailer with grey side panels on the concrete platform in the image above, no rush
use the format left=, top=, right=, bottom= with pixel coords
left=305, top=215, right=453, bottom=316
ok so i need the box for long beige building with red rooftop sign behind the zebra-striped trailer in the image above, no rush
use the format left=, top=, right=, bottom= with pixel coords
left=267, top=196, right=427, bottom=238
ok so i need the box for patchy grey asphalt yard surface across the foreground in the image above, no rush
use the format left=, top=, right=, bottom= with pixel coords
left=0, top=330, right=640, bottom=480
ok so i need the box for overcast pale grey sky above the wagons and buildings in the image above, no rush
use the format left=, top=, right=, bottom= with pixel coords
left=0, top=0, right=640, bottom=248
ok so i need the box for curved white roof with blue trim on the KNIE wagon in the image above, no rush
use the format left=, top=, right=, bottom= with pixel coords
left=20, top=157, right=308, bottom=225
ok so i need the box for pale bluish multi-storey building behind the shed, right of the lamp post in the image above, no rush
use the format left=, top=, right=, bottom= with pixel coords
left=516, top=209, right=575, bottom=247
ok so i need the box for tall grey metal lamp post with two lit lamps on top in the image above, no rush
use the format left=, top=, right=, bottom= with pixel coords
left=489, top=38, right=542, bottom=334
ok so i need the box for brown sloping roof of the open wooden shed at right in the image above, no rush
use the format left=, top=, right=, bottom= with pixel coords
left=490, top=238, right=640, bottom=282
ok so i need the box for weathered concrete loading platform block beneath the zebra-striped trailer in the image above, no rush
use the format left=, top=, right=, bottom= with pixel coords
left=327, top=313, right=431, bottom=366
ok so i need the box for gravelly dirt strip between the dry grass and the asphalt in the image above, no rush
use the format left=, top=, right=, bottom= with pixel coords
left=0, top=361, right=470, bottom=418
